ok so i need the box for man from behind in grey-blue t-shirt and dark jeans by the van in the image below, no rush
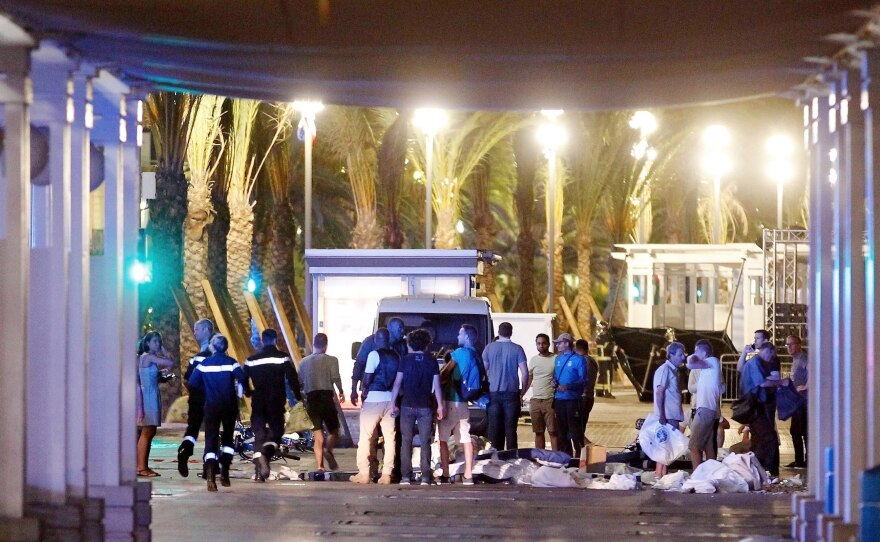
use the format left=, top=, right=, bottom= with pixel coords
left=483, top=322, right=529, bottom=450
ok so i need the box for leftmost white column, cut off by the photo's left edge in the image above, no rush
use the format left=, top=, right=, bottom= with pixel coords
left=0, top=45, right=31, bottom=523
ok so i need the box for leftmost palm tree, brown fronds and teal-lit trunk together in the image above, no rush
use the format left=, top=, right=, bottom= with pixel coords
left=146, top=92, right=201, bottom=374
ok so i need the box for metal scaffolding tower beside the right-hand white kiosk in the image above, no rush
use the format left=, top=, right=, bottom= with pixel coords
left=764, top=229, right=810, bottom=348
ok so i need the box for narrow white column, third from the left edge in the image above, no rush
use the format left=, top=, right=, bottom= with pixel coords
left=63, top=72, right=93, bottom=497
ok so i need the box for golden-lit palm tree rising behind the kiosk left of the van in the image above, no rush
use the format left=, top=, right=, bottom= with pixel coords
left=318, top=106, right=396, bottom=248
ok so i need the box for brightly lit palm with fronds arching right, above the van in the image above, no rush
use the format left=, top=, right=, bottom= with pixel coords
left=412, top=112, right=531, bottom=253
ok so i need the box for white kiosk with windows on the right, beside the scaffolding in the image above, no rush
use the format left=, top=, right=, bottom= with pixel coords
left=612, top=243, right=765, bottom=348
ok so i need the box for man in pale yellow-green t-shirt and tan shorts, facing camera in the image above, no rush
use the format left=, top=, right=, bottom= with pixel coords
left=528, top=333, right=559, bottom=450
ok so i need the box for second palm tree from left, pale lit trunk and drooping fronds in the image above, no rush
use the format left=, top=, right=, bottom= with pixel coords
left=181, top=95, right=225, bottom=357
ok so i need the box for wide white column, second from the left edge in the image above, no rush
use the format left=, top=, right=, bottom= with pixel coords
left=26, top=44, right=70, bottom=504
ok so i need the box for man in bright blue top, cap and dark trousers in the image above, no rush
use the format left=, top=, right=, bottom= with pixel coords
left=553, top=333, right=587, bottom=457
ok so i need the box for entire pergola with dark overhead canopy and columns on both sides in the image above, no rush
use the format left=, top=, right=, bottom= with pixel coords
left=0, top=0, right=880, bottom=540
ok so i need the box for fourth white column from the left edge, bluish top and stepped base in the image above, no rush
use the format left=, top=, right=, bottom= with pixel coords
left=87, top=72, right=137, bottom=538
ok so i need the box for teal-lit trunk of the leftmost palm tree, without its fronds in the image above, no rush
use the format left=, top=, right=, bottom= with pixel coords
left=148, top=167, right=187, bottom=405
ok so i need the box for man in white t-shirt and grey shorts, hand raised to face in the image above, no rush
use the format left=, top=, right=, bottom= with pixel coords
left=687, top=339, right=723, bottom=469
